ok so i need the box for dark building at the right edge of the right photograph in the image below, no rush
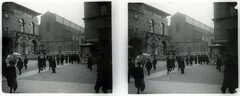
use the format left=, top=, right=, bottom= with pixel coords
left=213, top=2, right=238, bottom=61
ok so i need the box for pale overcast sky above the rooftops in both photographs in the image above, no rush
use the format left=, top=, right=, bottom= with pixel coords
left=7, top=0, right=238, bottom=28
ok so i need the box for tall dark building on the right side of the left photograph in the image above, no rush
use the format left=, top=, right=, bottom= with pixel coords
left=83, top=2, right=112, bottom=59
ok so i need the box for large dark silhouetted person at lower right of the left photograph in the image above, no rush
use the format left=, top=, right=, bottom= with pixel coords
left=94, top=52, right=112, bottom=93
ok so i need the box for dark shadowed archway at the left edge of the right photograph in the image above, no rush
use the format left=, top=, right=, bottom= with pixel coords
left=128, top=37, right=143, bottom=57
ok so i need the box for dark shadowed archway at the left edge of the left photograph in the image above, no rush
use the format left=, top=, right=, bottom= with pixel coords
left=2, top=37, right=14, bottom=57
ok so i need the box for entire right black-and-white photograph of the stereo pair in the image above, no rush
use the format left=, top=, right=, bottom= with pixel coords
left=127, top=1, right=238, bottom=94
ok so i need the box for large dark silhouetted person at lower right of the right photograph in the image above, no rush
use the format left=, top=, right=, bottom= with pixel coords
left=221, top=53, right=238, bottom=93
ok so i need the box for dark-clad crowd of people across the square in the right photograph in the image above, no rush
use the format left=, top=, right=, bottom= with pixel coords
left=128, top=54, right=238, bottom=94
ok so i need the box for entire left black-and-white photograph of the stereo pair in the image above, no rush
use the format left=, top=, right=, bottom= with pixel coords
left=1, top=1, right=112, bottom=94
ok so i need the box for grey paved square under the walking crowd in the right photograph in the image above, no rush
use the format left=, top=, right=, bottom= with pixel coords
left=128, top=64, right=226, bottom=94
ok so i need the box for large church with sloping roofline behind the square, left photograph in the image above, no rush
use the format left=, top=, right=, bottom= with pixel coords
left=39, top=11, right=85, bottom=54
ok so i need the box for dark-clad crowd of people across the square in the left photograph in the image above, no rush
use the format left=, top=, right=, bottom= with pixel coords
left=2, top=52, right=112, bottom=93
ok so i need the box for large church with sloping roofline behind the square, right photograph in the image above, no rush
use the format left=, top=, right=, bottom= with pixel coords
left=169, top=12, right=214, bottom=55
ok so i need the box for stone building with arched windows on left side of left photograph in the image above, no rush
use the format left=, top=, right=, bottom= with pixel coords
left=2, top=2, right=43, bottom=57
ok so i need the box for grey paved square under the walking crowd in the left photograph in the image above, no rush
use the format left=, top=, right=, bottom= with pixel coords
left=2, top=60, right=102, bottom=93
